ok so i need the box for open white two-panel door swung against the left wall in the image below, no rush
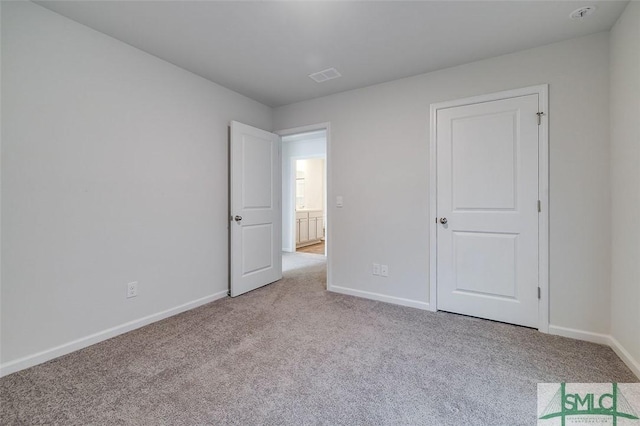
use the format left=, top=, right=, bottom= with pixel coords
left=229, top=121, right=282, bottom=297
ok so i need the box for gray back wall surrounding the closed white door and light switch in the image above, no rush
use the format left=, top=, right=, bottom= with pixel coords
left=274, top=33, right=611, bottom=333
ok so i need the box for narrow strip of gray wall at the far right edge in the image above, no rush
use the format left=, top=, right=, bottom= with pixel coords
left=611, top=2, right=640, bottom=374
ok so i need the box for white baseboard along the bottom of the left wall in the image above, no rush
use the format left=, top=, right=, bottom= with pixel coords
left=0, top=290, right=228, bottom=377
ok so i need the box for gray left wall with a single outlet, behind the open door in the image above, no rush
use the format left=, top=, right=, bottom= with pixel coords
left=1, top=2, right=272, bottom=364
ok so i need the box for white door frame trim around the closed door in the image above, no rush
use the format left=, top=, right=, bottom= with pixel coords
left=429, top=84, right=549, bottom=333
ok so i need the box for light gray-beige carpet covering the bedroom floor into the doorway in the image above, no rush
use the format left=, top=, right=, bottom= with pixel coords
left=0, top=254, right=638, bottom=425
